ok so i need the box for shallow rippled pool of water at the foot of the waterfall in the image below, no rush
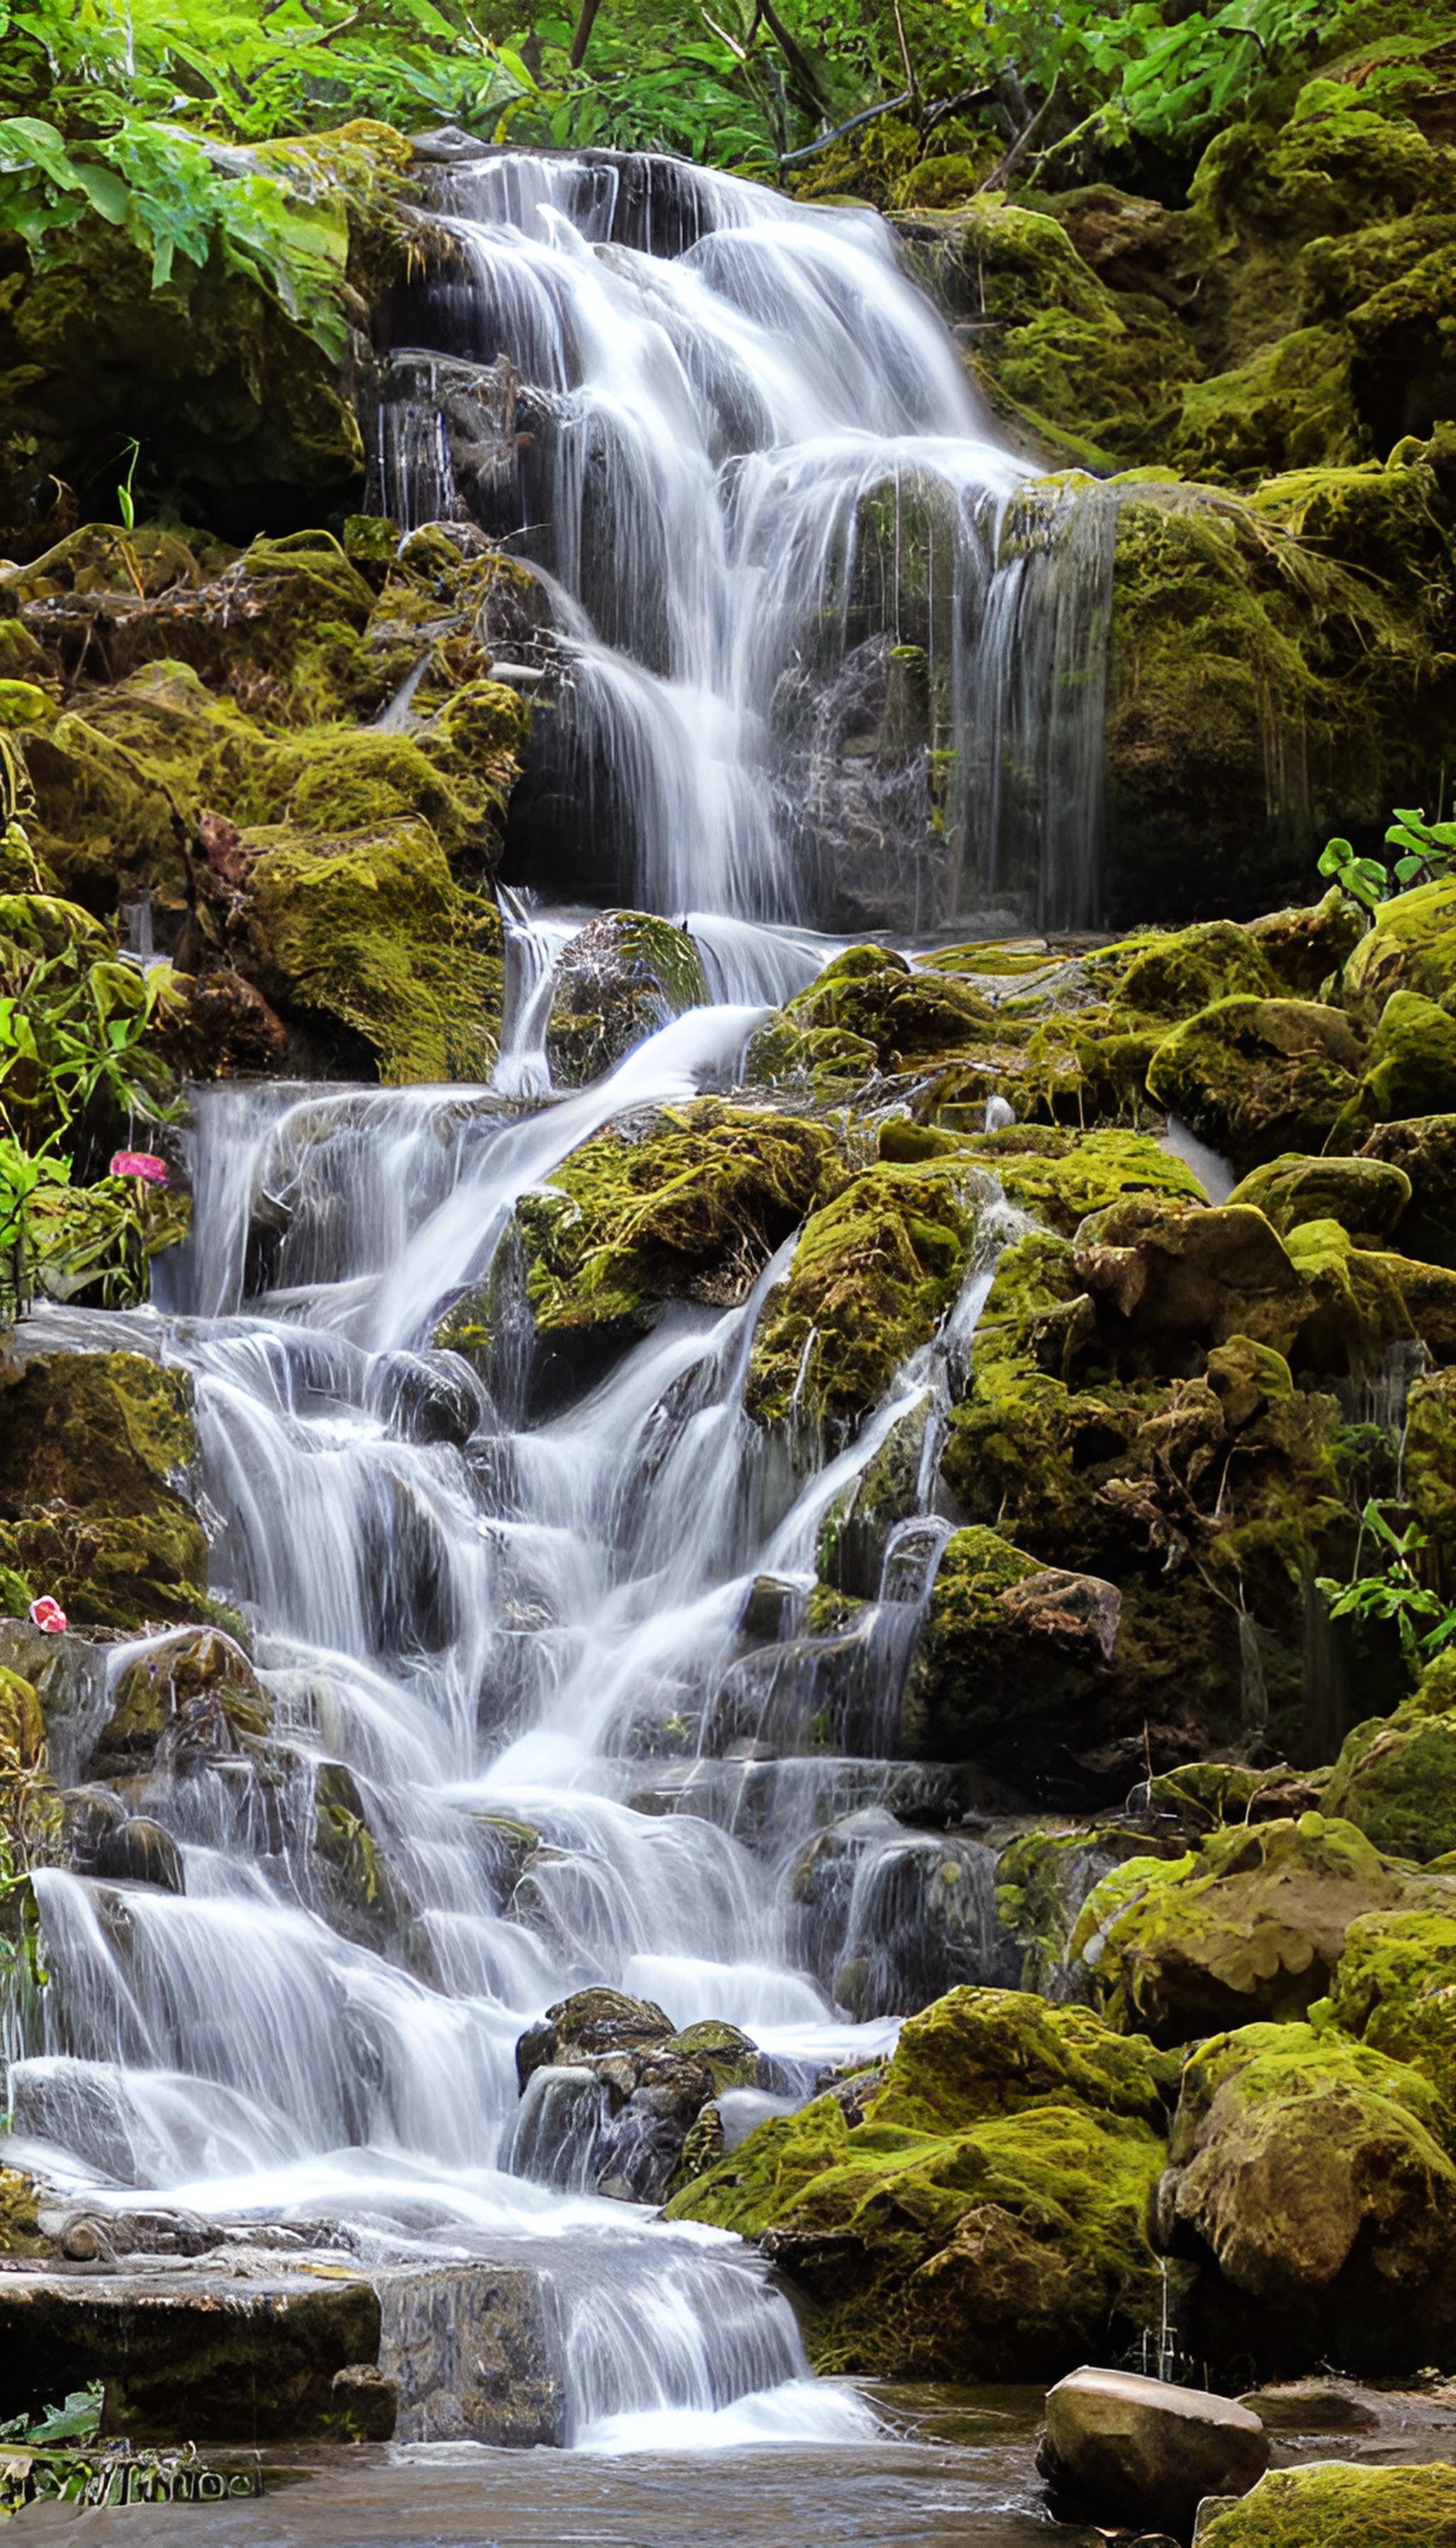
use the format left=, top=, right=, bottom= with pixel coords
left=16, top=2387, right=1101, bottom=2548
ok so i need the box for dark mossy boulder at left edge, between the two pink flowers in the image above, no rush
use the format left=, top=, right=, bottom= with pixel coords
left=0, top=1353, right=214, bottom=1628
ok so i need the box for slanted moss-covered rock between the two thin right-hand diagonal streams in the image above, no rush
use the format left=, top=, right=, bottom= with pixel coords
left=744, top=1160, right=995, bottom=1422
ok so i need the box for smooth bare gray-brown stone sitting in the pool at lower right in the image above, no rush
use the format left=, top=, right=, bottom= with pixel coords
left=1038, top=2365, right=1270, bottom=2538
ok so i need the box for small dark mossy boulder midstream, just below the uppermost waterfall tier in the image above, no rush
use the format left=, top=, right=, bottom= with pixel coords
left=546, top=912, right=707, bottom=1088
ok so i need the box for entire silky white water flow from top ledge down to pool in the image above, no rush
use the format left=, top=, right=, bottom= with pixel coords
left=10, top=140, right=1104, bottom=2448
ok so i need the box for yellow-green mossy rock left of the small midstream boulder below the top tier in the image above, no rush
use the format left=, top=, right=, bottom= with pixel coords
left=242, top=820, right=505, bottom=1083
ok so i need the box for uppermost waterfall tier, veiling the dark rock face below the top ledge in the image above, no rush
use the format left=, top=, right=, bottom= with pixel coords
left=373, top=135, right=1117, bottom=935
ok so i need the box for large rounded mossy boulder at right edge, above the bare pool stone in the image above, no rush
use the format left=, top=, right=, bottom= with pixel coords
left=1160, top=2025, right=1456, bottom=2375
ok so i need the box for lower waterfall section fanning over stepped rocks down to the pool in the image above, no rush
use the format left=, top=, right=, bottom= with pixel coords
left=10, top=1009, right=1002, bottom=2446
